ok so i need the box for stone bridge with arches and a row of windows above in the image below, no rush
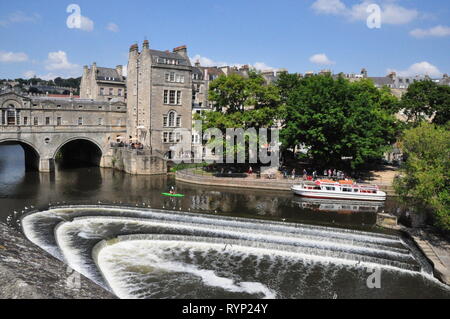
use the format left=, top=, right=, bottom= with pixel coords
left=0, top=93, right=126, bottom=172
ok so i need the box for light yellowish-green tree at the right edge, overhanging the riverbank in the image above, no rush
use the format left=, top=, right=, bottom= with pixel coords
left=394, top=122, right=450, bottom=231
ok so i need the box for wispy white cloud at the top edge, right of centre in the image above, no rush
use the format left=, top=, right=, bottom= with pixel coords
left=311, top=0, right=419, bottom=25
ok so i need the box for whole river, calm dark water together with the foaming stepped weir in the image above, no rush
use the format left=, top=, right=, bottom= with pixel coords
left=0, top=146, right=450, bottom=298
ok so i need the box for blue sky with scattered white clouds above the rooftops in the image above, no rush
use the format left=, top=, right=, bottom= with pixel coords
left=0, top=0, right=450, bottom=78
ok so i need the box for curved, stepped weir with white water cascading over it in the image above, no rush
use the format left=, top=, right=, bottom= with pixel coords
left=22, top=206, right=449, bottom=298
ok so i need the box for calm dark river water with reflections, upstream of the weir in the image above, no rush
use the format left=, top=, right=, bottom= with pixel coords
left=0, top=146, right=382, bottom=229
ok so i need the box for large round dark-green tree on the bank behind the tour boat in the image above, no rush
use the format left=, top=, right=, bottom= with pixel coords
left=281, top=75, right=396, bottom=169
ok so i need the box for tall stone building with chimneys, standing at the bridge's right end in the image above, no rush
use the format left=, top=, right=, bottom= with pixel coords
left=127, top=40, right=192, bottom=159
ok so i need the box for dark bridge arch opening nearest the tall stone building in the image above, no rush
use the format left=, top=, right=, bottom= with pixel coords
left=53, top=137, right=104, bottom=167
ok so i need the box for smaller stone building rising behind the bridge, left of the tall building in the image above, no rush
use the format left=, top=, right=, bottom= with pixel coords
left=80, top=62, right=126, bottom=102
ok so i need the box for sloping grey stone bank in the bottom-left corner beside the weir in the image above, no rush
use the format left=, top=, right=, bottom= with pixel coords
left=0, top=223, right=116, bottom=299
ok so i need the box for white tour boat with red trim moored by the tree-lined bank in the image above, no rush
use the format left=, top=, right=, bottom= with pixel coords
left=291, top=180, right=386, bottom=201
